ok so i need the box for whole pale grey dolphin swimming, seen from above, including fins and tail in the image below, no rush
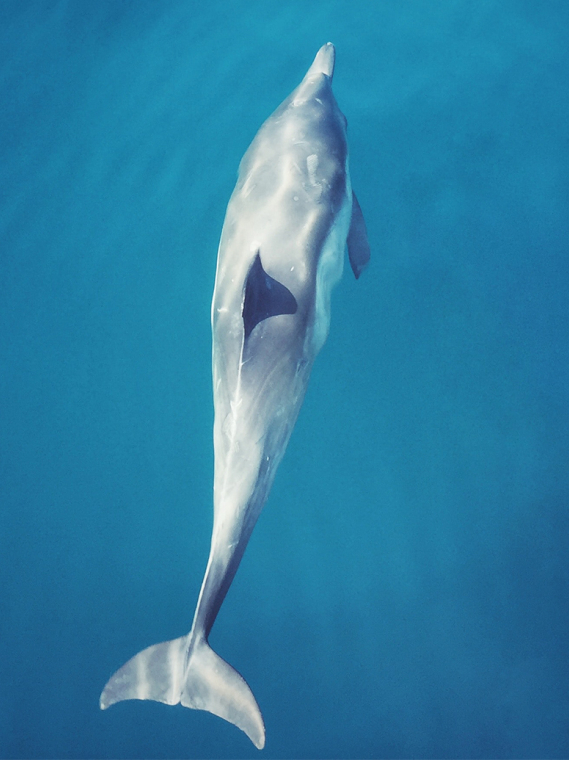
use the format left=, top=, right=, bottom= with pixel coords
left=101, top=43, right=369, bottom=749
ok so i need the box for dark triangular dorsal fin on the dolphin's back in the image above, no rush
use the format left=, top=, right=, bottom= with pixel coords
left=243, top=251, right=298, bottom=340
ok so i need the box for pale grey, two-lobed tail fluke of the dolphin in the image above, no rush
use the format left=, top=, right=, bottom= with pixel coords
left=100, top=636, right=265, bottom=749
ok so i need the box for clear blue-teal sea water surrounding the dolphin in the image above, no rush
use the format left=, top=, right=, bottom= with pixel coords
left=0, top=0, right=569, bottom=758
